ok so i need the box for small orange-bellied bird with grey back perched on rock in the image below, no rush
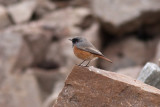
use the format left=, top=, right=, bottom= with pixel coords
left=69, top=36, right=112, bottom=67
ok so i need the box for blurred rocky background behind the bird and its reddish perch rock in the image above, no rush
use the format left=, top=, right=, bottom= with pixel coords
left=0, top=0, right=160, bottom=107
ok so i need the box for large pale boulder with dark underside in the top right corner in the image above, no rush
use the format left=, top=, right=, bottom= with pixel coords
left=91, top=0, right=160, bottom=36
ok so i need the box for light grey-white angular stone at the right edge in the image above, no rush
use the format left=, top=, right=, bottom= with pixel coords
left=137, top=63, right=160, bottom=89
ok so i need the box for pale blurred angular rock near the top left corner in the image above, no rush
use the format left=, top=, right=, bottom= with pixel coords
left=8, top=1, right=36, bottom=24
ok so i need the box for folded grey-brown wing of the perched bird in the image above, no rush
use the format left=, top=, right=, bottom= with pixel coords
left=77, top=43, right=104, bottom=56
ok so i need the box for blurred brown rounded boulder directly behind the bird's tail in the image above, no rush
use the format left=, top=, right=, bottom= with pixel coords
left=100, top=37, right=157, bottom=71
